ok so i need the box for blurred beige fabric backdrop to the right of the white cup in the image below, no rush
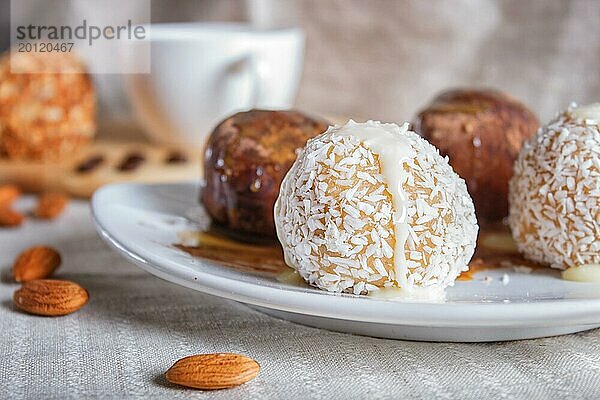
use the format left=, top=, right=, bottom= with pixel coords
left=249, top=0, right=600, bottom=121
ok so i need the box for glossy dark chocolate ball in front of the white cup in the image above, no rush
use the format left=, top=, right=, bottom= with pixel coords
left=200, top=110, right=328, bottom=239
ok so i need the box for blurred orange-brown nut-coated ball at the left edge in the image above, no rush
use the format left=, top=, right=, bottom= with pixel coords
left=0, top=51, right=96, bottom=161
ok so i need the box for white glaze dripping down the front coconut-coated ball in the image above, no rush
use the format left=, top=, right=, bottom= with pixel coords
left=336, top=120, right=414, bottom=286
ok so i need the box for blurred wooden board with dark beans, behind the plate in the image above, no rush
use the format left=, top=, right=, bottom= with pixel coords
left=0, top=140, right=202, bottom=198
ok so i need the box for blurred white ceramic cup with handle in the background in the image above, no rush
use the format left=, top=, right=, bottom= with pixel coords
left=121, top=23, right=304, bottom=146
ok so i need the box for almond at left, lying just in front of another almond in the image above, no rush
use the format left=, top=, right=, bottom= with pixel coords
left=13, top=279, right=89, bottom=317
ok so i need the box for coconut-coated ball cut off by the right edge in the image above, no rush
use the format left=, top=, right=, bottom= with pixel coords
left=509, top=103, right=600, bottom=269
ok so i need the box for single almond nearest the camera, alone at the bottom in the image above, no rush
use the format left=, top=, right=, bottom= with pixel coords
left=165, top=353, right=260, bottom=390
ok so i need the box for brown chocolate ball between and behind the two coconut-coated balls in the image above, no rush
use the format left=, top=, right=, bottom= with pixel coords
left=415, top=89, right=539, bottom=223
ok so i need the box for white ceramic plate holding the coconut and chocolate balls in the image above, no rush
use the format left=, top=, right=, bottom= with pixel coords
left=92, top=183, right=600, bottom=342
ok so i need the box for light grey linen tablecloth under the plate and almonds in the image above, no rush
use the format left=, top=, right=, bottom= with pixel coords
left=0, top=198, right=600, bottom=399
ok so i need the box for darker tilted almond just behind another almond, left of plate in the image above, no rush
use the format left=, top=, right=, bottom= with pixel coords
left=12, top=246, right=60, bottom=282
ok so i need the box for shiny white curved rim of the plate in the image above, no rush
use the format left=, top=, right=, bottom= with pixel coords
left=91, top=181, right=600, bottom=329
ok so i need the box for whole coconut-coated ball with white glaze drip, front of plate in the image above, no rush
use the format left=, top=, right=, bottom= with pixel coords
left=275, top=121, right=478, bottom=294
